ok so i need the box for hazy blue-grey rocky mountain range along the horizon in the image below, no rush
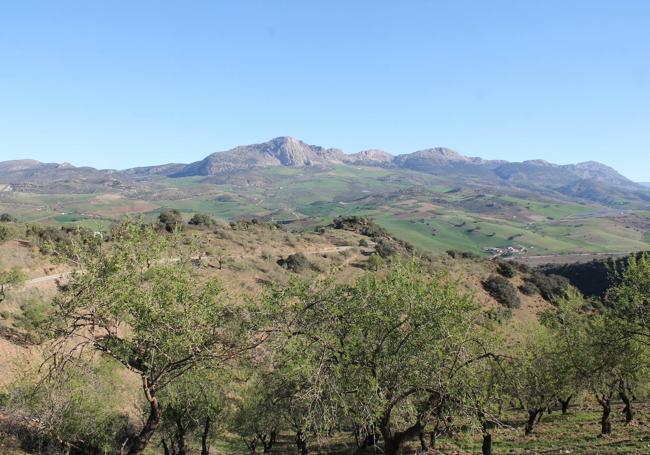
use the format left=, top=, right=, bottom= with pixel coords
left=0, top=137, right=650, bottom=205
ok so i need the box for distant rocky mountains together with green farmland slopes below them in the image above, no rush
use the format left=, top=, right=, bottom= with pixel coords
left=0, top=137, right=650, bottom=255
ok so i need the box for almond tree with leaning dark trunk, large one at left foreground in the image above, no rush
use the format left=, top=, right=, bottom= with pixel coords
left=48, top=222, right=252, bottom=455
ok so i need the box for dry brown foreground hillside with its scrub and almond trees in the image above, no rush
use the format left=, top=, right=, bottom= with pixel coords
left=0, top=216, right=647, bottom=454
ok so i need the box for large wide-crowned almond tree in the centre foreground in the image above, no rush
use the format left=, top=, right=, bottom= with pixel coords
left=276, top=262, right=489, bottom=455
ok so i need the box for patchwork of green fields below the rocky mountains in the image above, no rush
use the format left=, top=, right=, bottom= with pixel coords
left=0, top=166, right=650, bottom=255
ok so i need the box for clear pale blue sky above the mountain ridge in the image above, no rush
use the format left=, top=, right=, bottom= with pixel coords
left=0, top=0, right=650, bottom=181
